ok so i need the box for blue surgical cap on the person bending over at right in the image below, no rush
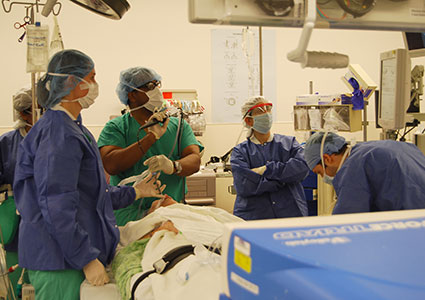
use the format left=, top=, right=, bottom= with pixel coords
left=304, top=131, right=346, bottom=170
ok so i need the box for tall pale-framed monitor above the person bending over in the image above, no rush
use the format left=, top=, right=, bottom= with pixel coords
left=378, top=49, right=410, bottom=130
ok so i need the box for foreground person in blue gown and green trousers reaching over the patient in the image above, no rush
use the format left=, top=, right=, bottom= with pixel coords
left=14, top=50, right=165, bottom=300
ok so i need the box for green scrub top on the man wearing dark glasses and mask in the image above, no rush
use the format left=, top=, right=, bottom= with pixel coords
left=98, top=113, right=204, bottom=226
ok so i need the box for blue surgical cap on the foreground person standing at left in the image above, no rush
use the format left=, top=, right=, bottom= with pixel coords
left=37, top=49, right=94, bottom=108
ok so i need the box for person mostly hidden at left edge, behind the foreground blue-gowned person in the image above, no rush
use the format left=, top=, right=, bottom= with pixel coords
left=0, top=87, right=32, bottom=292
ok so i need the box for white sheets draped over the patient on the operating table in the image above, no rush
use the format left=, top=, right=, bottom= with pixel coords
left=81, top=204, right=242, bottom=300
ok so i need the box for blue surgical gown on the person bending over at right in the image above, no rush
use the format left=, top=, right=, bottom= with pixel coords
left=332, top=140, right=425, bottom=214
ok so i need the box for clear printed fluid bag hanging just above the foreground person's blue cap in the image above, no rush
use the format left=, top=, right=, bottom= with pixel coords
left=27, top=25, right=49, bottom=73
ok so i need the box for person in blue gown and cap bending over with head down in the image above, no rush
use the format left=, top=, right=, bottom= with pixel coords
left=305, top=132, right=425, bottom=214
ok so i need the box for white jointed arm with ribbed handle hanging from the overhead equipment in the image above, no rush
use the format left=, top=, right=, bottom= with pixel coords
left=287, top=0, right=349, bottom=69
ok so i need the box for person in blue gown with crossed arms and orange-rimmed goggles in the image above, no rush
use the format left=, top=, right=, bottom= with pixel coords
left=230, top=96, right=309, bottom=220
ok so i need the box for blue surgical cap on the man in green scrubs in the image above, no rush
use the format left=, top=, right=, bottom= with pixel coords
left=115, top=67, right=162, bottom=105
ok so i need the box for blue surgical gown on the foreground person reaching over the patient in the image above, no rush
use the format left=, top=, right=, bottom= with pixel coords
left=14, top=110, right=136, bottom=271
